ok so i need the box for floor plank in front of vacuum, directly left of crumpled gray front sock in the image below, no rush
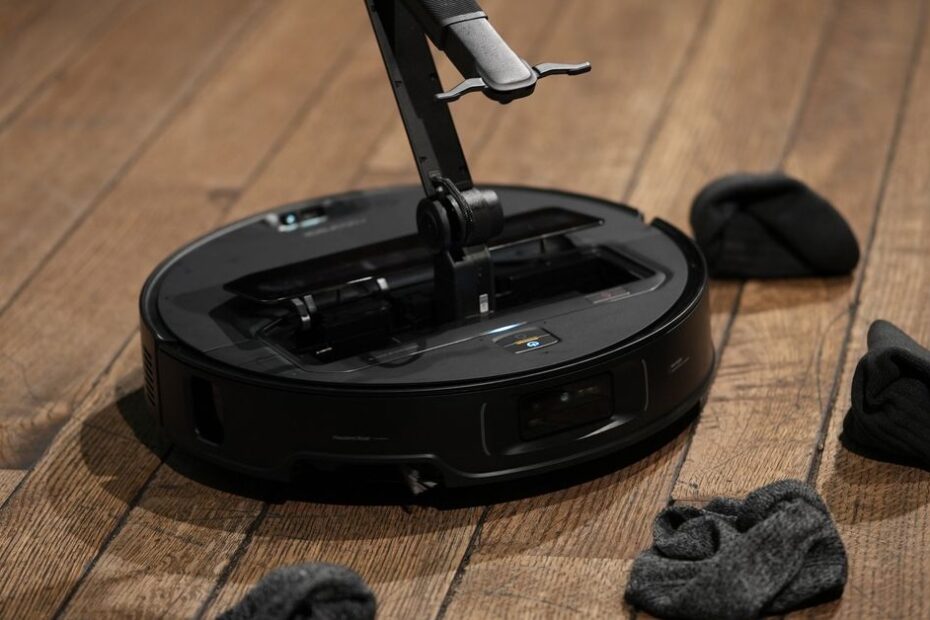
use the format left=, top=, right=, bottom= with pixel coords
left=443, top=436, right=682, bottom=618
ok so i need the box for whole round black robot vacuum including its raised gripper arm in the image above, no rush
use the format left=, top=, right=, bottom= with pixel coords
left=140, top=0, right=714, bottom=486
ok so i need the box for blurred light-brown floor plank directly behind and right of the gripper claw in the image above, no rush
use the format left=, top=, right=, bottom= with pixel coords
left=473, top=1, right=706, bottom=199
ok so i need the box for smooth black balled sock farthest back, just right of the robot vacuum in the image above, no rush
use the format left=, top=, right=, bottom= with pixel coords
left=691, top=173, right=859, bottom=278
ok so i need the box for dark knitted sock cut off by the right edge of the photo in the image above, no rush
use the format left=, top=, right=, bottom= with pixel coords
left=840, top=321, right=930, bottom=470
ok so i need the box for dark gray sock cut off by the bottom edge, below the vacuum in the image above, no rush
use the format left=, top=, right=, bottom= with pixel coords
left=218, top=563, right=376, bottom=620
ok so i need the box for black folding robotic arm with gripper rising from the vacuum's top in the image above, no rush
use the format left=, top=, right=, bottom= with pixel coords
left=365, top=0, right=591, bottom=321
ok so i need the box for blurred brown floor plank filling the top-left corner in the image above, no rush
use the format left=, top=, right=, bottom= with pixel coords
left=0, top=0, right=133, bottom=128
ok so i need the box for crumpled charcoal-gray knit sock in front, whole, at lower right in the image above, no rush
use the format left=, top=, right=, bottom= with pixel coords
left=626, top=480, right=846, bottom=619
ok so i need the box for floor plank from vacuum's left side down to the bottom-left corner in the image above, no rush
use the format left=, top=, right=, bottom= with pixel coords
left=0, top=342, right=163, bottom=618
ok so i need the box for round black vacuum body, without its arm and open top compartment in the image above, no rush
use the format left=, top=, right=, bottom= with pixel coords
left=141, top=187, right=714, bottom=485
